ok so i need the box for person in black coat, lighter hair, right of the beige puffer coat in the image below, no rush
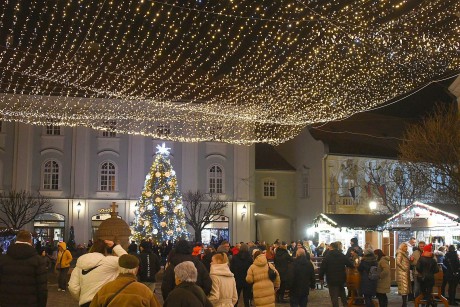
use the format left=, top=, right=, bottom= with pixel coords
left=288, top=249, right=316, bottom=307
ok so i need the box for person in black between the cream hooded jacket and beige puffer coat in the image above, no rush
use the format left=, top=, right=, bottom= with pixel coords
left=230, top=243, right=252, bottom=307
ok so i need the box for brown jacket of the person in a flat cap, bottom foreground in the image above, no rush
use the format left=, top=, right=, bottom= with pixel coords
left=90, top=274, right=161, bottom=307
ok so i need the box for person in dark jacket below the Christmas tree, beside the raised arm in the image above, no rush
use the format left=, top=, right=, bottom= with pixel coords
left=137, top=240, right=161, bottom=292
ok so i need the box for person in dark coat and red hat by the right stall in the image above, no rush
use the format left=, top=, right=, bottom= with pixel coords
left=416, top=244, right=439, bottom=306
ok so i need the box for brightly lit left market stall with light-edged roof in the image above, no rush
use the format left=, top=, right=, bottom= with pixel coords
left=309, top=213, right=389, bottom=250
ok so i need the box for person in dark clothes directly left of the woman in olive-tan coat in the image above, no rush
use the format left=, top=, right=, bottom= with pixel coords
left=358, top=248, right=379, bottom=307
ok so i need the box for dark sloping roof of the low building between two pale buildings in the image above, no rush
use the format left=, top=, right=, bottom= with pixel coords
left=255, top=143, right=295, bottom=171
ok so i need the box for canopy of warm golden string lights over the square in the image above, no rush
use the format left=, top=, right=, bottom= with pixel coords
left=0, top=0, right=460, bottom=144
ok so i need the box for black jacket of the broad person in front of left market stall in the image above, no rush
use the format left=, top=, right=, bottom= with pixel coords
left=319, top=249, right=354, bottom=286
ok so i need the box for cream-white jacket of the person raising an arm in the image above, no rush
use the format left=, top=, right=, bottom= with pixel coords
left=69, top=245, right=126, bottom=305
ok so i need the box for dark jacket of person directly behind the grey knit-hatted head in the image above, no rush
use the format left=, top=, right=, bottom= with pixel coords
left=161, top=254, right=212, bottom=300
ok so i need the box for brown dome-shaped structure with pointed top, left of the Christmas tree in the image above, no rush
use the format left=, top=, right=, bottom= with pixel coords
left=96, top=202, right=131, bottom=250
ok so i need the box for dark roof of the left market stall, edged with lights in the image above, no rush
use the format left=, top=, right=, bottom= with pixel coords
left=313, top=213, right=390, bottom=230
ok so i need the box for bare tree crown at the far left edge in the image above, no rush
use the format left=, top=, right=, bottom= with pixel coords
left=0, top=190, right=52, bottom=229
